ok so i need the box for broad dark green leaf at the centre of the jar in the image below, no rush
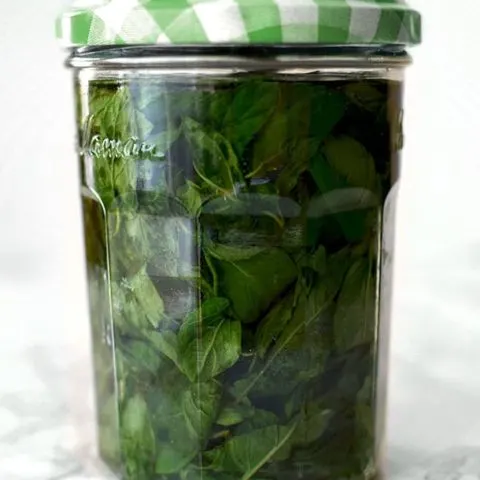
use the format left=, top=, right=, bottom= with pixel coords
left=218, top=249, right=297, bottom=323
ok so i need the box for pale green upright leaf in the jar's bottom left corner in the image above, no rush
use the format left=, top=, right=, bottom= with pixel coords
left=120, top=395, right=156, bottom=480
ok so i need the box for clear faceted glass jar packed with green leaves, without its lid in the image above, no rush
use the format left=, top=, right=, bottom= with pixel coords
left=58, top=1, right=418, bottom=480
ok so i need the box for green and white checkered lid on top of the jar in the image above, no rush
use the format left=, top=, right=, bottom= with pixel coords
left=57, top=0, right=421, bottom=47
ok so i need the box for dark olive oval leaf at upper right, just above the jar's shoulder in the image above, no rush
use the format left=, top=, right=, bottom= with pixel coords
left=323, top=135, right=376, bottom=191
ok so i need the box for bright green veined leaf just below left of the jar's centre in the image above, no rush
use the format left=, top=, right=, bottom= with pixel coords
left=179, top=320, right=242, bottom=381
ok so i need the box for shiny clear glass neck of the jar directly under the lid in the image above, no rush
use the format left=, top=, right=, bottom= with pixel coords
left=67, top=45, right=411, bottom=71
